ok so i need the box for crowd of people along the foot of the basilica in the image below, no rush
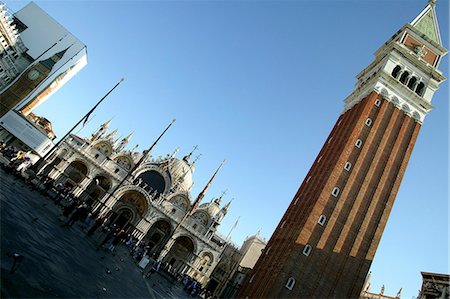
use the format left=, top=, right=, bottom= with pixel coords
left=0, top=141, right=214, bottom=297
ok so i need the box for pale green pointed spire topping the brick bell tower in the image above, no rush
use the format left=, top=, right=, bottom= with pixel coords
left=411, top=1, right=442, bottom=46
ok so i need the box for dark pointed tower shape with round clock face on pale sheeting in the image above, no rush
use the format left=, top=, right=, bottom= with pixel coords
left=0, top=48, right=68, bottom=117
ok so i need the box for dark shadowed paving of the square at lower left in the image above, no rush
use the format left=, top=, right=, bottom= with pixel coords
left=0, top=168, right=195, bottom=298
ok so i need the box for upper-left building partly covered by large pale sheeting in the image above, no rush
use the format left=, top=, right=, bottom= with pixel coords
left=0, top=2, right=87, bottom=155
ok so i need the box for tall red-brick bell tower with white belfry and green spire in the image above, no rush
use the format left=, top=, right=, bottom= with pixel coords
left=239, top=1, right=447, bottom=298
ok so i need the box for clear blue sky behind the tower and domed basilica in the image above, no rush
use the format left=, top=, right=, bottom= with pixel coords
left=7, top=0, right=449, bottom=299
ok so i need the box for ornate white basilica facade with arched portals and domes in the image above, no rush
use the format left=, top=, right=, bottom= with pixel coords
left=40, top=121, right=230, bottom=285
